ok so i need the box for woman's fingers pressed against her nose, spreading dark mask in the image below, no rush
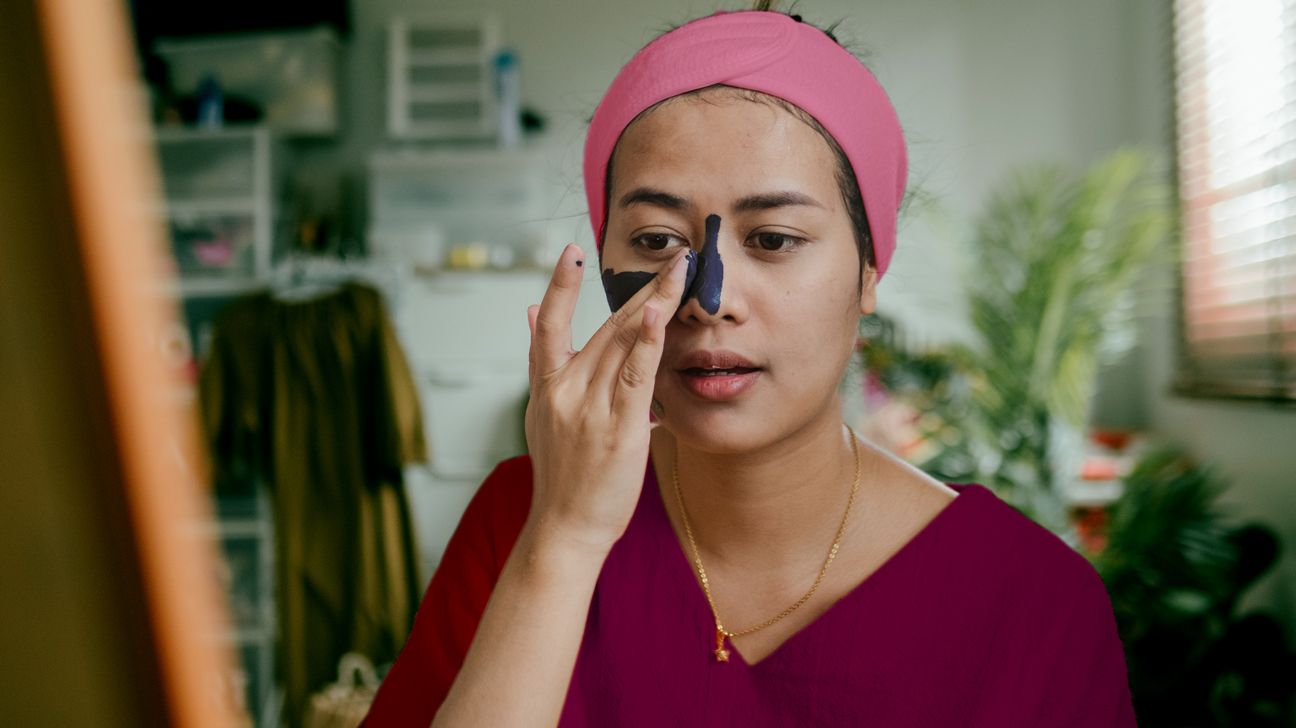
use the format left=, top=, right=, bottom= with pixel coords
left=583, top=247, right=687, bottom=398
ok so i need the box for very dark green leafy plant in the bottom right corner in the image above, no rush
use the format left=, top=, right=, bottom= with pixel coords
left=1091, top=448, right=1296, bottom=728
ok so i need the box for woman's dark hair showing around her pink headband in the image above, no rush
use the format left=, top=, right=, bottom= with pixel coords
left=599, top=0, right=877, bottom=289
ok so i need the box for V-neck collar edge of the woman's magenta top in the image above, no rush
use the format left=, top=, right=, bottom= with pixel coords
left=643, top=455, right=994, bottom=670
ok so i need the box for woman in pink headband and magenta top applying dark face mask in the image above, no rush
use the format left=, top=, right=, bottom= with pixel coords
left=369, top=10, right=1134, bottom=727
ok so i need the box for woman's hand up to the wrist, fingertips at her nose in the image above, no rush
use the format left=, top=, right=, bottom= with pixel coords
left=526, top=245, right=687, bottom=553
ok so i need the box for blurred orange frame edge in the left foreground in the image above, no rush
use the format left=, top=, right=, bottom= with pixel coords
left=30, top=0, right=246, bottom=727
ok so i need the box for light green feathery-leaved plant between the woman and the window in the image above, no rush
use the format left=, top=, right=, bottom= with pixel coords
left=862, top=149, right=1174, bottom=530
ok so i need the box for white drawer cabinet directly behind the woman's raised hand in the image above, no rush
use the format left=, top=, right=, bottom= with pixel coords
left=368, top=145, right=608, bottom=579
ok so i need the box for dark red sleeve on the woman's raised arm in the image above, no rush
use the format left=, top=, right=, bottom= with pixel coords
left=364, top=455, right=531, bottom=728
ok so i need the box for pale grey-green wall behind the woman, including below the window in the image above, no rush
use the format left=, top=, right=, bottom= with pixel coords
left=311, top=0, right=1296, bottom=636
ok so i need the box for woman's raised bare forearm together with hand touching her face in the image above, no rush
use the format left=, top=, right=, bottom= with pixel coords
left=433, top=245, right=686, bottom=727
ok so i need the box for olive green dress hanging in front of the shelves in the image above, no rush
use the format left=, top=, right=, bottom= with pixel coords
left=200, top=284, right=426, bottom=725
